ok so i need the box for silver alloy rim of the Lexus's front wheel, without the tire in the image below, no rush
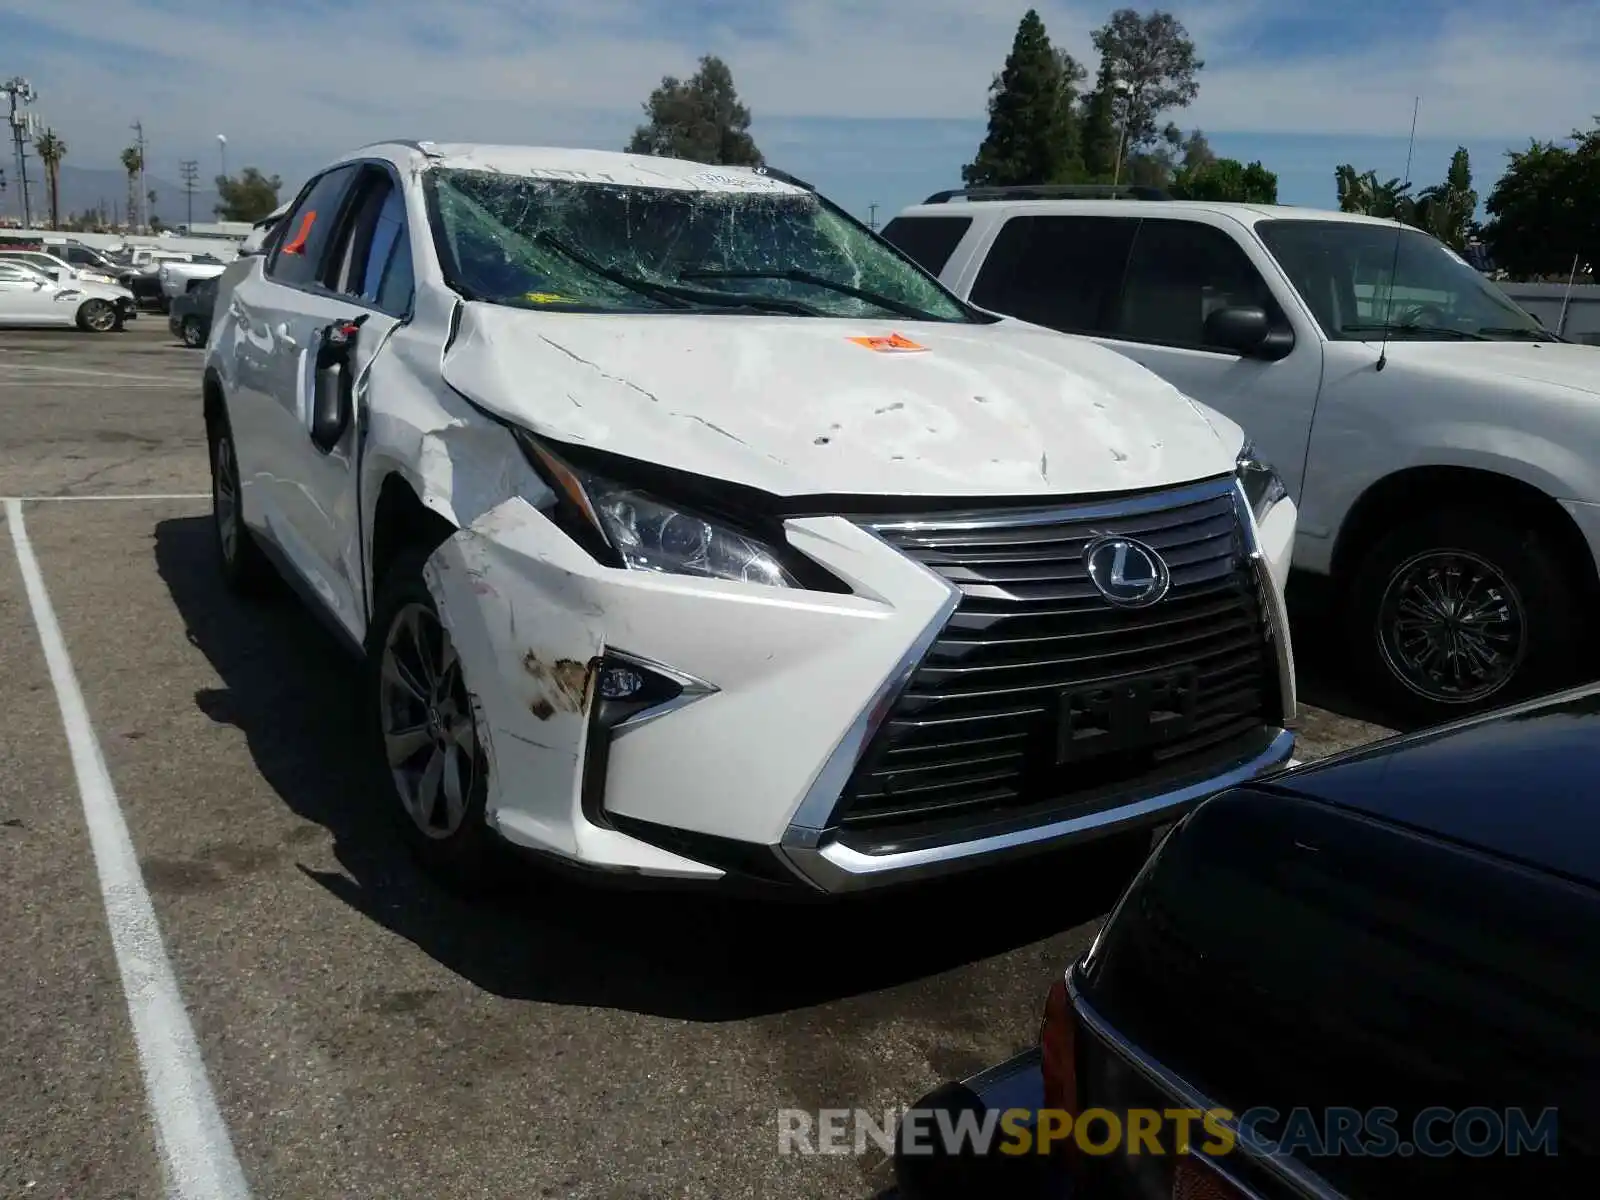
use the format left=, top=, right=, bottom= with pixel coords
left=378, top=602, right=482, bottom=838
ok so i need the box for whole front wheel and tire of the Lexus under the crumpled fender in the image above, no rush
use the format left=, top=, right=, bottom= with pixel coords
left=366, top=546, right=499, bottom=891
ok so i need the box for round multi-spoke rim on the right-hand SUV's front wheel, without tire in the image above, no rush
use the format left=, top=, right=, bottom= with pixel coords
left=1378, top=550, right=1528, bottom=704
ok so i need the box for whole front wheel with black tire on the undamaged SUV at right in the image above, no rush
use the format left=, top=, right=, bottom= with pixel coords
left=1347, top=509, right=1581, bottom=725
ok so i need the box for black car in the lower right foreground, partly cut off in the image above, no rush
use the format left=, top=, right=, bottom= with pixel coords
left=896, top=686, right=1600, bottom=1200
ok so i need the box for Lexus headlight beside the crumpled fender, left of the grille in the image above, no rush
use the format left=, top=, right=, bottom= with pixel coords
left=517, top=435, right=800, bottom=587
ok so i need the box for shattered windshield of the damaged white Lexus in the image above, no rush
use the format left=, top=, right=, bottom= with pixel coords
left=429, top=168, right=973, bottom=322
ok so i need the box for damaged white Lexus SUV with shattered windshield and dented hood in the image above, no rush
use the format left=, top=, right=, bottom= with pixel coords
left=205, top=142, right=1296, bottom=894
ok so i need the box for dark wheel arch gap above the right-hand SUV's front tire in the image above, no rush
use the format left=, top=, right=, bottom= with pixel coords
left=1331, top=466, right=1600, bottom=598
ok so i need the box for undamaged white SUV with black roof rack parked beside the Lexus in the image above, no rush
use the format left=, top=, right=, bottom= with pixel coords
left=883, top=187, right=1600, bottom=722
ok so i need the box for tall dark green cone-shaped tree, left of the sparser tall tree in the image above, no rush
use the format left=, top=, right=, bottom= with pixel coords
left=962, top=8, right=1075, bottom=187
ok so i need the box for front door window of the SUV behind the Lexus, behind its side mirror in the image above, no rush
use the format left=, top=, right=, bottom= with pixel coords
left=1112, top=218, right=1283, bottom=354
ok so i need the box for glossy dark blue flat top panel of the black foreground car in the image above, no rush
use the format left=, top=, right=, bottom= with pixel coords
left=1269, top=685, right=1600, bottom=886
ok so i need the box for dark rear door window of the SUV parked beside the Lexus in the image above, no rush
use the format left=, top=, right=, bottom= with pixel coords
left=971, top=216, right=1139, bottom=333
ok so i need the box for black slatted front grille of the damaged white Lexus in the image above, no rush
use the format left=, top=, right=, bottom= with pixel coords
left=835, top=486, right=1282, bottom=843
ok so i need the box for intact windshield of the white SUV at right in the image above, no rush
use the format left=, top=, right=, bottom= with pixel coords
left=1256, top=221, right=1554, bottom=341
